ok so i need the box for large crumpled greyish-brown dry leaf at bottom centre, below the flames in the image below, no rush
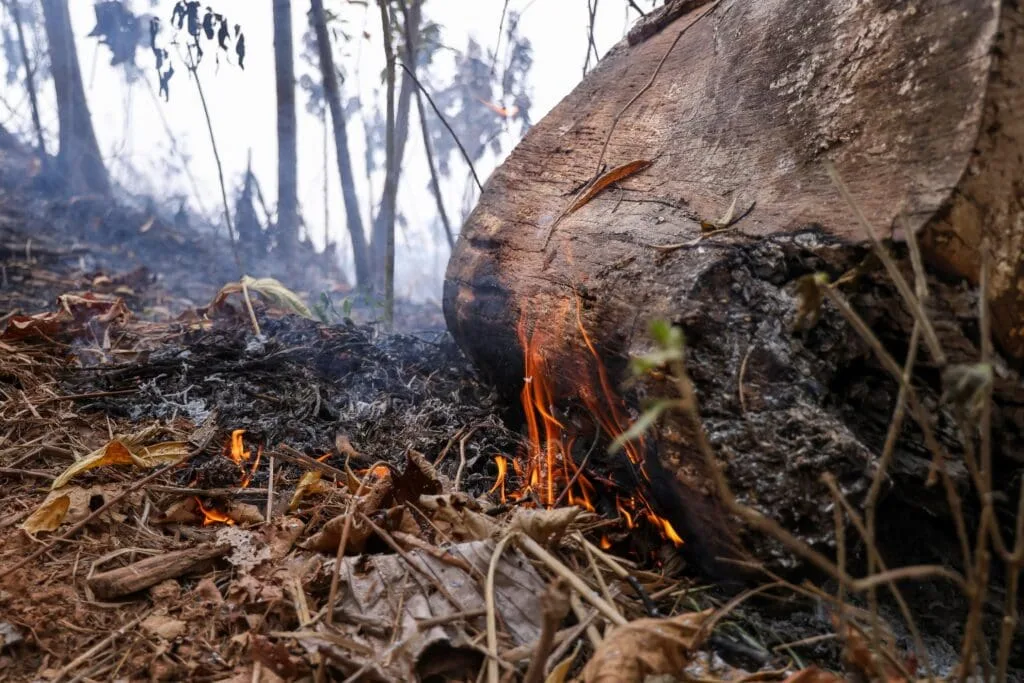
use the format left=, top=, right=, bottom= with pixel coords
left=294, top=541, right=546, bottom=681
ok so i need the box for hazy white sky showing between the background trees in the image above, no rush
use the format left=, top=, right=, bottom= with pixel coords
left=6, top=0, right=650, bottom=299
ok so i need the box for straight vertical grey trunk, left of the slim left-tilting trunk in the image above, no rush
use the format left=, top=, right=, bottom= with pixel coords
left=273, top=0, right=299, bottom=261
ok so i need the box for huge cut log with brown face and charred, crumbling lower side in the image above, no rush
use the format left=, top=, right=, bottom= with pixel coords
left=444, top=0, right=1024, bottom=577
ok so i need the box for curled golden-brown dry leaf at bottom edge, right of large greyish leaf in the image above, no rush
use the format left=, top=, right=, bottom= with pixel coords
left=583, top=609, right=713, bottom=683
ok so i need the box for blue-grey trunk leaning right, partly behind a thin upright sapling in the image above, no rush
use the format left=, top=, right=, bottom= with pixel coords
left=372, top=0, right=423, bottom=290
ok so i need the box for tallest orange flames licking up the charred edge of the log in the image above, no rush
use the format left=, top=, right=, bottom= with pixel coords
left=505, top=298, right=683, bottom=547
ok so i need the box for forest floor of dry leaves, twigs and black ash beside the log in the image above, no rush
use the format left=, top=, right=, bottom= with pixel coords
left=0, top=136, right=962, bottom=683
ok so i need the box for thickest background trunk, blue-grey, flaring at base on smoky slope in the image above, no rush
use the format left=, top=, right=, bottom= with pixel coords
left=42, top=0, right=111, bottom=195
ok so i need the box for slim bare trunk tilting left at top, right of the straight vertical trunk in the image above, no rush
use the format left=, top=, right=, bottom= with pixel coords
left=310, top=0, right=372, bottom=288
